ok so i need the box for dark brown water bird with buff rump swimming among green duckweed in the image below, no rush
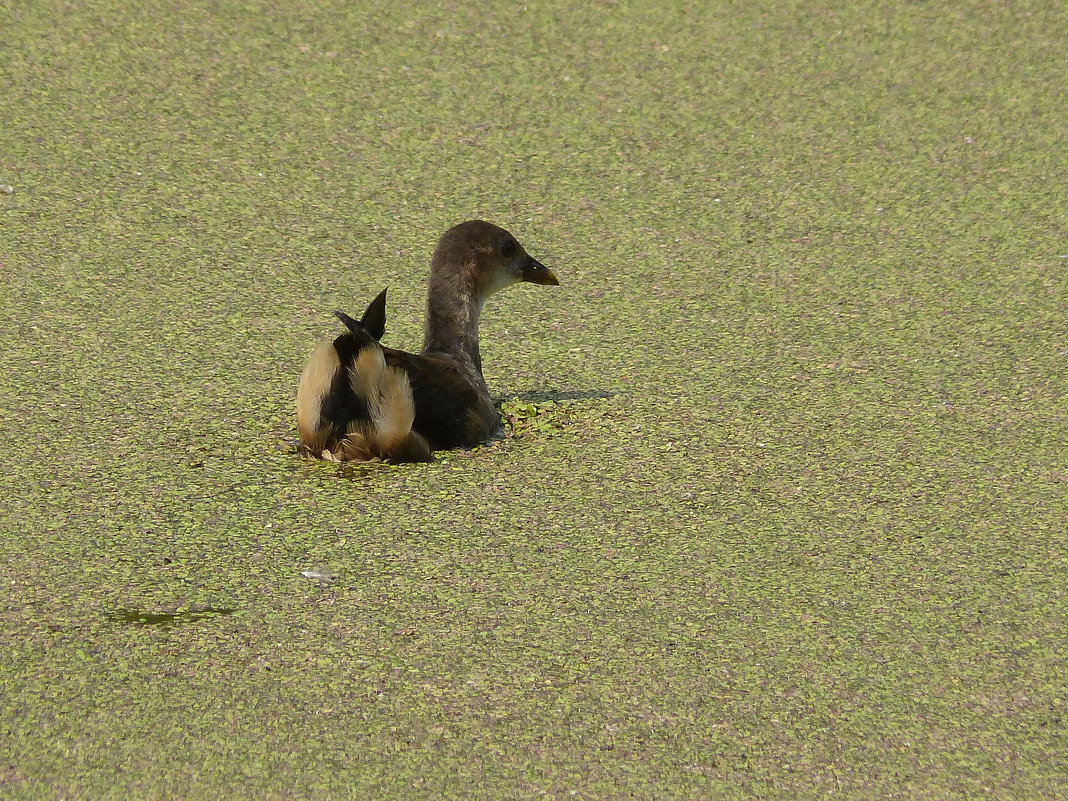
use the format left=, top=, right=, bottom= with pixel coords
left=297, top=220, right=560, bottom=464
